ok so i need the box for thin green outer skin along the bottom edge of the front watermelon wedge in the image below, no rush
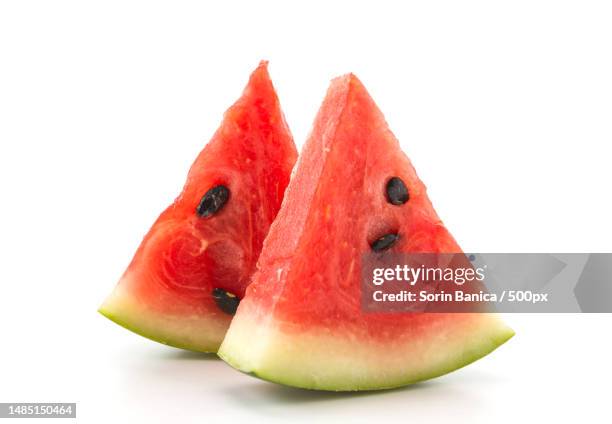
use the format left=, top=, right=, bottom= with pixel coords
left=217, top=314, right=515, bottom=392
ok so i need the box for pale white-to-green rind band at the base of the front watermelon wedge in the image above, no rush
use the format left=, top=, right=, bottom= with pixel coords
left=218, top=305, right=514, bottom=391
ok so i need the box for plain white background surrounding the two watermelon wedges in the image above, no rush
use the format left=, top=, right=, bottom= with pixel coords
left=0, top=0, right=612, bottom=423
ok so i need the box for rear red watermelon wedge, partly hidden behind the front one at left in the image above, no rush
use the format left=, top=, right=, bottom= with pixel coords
left=100, top=62, right=297, bottom=352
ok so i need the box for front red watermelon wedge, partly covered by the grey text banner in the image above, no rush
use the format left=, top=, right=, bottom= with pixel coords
left=219, top=75, right=514, bottom=391
